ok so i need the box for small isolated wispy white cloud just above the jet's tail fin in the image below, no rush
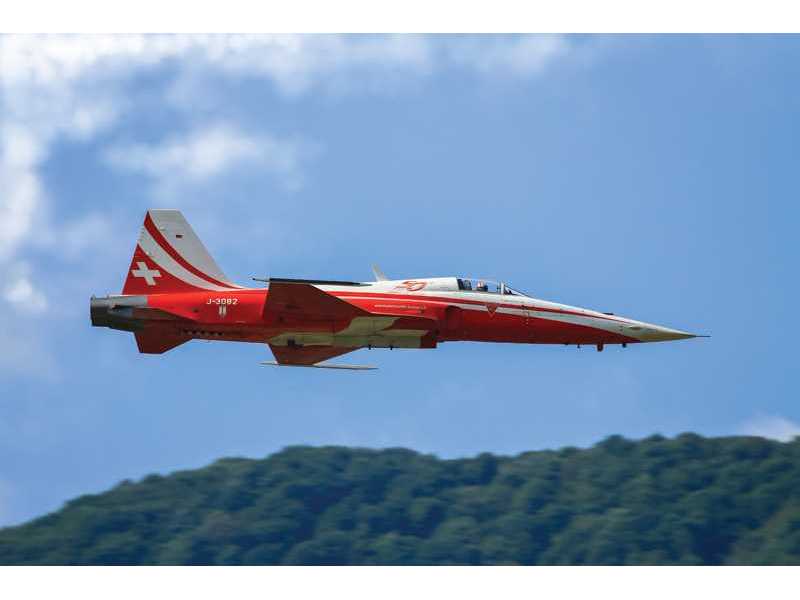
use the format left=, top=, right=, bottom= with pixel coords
left=106, top=123, right=314, bottom=187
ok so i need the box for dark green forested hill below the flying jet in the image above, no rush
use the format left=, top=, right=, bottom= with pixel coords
left=0, top=434, right=800, bottom=564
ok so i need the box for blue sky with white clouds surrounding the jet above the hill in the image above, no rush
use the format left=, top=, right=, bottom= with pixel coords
left=0, top=36, right=800, bottom=525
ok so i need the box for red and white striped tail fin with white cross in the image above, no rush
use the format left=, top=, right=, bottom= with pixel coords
left=122, top=209, right=240, bottom=295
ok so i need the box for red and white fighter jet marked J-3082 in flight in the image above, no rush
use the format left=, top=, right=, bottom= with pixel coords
left=90, top=210, right=698, bottom=369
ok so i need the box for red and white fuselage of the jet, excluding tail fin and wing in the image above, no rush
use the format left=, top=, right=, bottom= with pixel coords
left=92, top=279, right=694, bottom=348
